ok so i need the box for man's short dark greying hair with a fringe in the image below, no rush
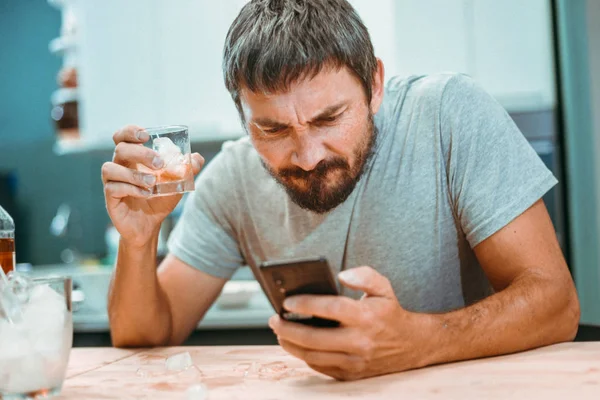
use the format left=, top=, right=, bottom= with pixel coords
left=223, top=0, right=377, bottom=120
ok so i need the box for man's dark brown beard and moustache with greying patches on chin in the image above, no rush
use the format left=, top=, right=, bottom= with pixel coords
left=261, top=112, right=377, bottom=214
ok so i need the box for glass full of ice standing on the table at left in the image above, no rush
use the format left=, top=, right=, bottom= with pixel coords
left=0, top=277, right=73, bottom=400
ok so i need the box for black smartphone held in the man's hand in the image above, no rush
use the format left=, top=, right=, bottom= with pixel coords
left=260, top=257, right=340, bottom=327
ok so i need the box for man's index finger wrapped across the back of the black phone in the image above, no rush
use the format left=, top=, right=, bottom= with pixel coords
left=283, top=295, right=362, bottom=325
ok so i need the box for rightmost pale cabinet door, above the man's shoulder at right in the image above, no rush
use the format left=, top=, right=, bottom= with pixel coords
left=469, top=0, right=556, bottom=112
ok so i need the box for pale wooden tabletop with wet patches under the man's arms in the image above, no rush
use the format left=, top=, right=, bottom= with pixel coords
left=59, top=342, right=600, bottom=400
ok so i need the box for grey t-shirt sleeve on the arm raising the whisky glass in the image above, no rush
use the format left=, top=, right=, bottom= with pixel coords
left=168, top=145, right=244, bottom=279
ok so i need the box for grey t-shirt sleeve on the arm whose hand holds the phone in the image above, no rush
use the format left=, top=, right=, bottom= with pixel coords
left=440, top=75, right=557, bottom=247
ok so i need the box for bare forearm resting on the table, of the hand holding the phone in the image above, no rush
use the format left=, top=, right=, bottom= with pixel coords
left=420, top=273, right=579, bottom=364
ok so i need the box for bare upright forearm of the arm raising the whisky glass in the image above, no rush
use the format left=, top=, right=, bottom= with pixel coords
left=108, top=234, right=172, bottom=347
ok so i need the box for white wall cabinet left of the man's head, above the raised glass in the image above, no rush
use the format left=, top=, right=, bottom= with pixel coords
left=77, top=0, right=245, bottom=148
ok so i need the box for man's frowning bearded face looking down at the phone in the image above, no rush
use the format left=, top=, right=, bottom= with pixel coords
left=240, top=68, right=380, bottom=213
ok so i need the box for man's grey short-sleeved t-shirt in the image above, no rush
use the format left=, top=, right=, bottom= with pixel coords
left=169, top=74, right=557, bottom=312
